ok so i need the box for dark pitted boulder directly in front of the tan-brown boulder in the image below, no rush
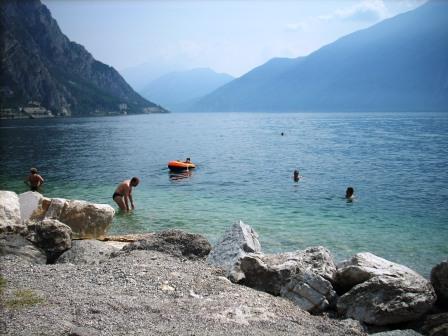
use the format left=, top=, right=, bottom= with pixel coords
left=27, top=218, right=72, bottom=263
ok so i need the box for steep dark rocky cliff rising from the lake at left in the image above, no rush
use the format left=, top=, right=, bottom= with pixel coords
left=0, top=0, right=166, bottom=116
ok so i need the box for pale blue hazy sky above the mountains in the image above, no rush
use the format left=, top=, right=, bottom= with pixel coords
left=43, top=0, right=425, bottom=77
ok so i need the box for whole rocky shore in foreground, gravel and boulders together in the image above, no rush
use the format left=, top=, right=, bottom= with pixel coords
left=0, top=191, right=448, bottom=336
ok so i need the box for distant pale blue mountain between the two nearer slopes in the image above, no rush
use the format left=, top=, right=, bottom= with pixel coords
left=141, top=68, right=234, bottom=111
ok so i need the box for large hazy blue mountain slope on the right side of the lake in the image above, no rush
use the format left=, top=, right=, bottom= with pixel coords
left=191, top=1, right=448, bottom=111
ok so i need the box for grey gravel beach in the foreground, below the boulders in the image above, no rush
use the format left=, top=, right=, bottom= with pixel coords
left=0, top=250, right=366, bottom=336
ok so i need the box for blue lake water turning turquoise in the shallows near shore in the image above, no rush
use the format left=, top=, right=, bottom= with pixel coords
left=0, top=113, right=448, bottom=275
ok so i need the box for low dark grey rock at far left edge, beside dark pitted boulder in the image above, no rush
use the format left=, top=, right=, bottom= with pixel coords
left=0, top=234, right=47, bottom=264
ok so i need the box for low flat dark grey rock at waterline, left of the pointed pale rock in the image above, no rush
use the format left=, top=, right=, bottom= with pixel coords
left=123, top=230, right=211, bottom=259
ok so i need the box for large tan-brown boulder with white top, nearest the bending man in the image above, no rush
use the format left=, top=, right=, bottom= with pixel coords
left=45, top=198, right=115, bottom=239
